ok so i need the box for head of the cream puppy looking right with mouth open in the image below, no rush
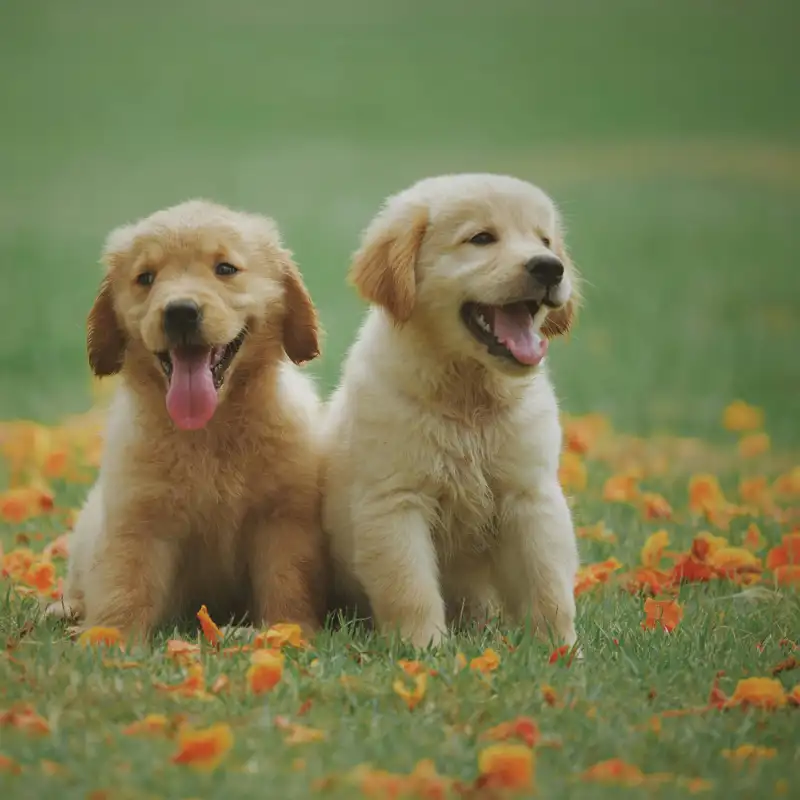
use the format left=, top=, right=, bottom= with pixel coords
left=350, top=175, right=579, bottom=374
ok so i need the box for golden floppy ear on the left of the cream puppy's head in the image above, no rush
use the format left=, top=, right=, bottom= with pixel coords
left=349, top=206, right=428, bottom=322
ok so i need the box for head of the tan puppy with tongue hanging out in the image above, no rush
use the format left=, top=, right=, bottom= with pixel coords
left=88, top=200, right=319, bottom=429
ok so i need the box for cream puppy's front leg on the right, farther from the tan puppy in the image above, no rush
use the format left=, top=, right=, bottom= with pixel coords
left=495, top=481, right=578, bottom=645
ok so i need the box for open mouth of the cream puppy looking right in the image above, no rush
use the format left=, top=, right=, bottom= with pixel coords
left=461, top=300, right=547, bottom=367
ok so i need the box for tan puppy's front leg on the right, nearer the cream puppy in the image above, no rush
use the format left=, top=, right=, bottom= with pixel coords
left=248, top=514, right=327, bottom=633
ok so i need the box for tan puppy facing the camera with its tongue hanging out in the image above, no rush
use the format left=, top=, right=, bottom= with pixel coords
left=51, top=200, right=326, bottom=635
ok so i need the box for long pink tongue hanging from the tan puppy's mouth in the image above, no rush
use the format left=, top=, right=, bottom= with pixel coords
left=167, top=350, right=217, bottom=431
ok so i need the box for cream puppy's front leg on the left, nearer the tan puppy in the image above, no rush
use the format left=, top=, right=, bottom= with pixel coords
left=353, top=506, right=446, bottom=647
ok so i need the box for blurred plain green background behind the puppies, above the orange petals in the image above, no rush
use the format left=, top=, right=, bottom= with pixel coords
left=0, top=0, right=800, bottom=446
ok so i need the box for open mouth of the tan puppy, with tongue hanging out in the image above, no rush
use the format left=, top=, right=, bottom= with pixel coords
left=156, top=329, right=247, bottom=430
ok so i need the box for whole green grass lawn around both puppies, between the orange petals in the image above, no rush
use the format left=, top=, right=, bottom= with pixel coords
left=0, top=0, right=800, bottom=798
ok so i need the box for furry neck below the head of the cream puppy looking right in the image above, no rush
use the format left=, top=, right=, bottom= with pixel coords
left=361, top=310, right=536, bottom=424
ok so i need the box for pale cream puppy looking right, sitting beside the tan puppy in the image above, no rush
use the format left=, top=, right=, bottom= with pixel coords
left=323, top=175, right=578, bottom=646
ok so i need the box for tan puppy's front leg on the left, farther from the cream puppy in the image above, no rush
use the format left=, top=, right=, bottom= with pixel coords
left=84, top=502, right=177, bottom=637
